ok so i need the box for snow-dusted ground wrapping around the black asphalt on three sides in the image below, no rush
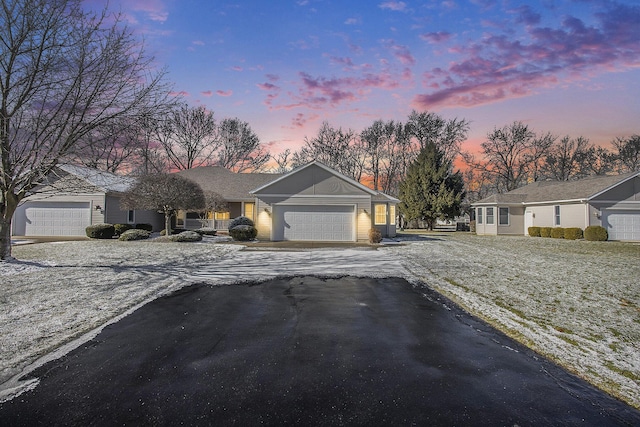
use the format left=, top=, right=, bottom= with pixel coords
left=0, top=233, right=640, bottom=407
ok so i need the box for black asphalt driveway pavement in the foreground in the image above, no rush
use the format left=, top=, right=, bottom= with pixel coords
left=0, top=277, right=640, bottom=426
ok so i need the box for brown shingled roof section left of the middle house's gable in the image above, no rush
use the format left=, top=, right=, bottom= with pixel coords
left=177, top=166, right=282, bottom=201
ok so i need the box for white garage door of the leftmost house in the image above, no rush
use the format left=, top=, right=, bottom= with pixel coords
left=13, top=202, right=91, bottom=236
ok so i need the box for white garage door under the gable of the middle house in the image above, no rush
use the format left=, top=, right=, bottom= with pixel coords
left=274, top=206, right=356, bottom=242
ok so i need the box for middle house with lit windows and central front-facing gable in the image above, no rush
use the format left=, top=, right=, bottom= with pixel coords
left=172, top=161, right=399, bottom=242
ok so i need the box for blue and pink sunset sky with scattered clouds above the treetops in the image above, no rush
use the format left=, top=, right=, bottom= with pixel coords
left=86, top=0, right=640, bottom=156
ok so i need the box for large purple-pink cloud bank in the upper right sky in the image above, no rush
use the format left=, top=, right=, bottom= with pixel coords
left=413, top=4, right=640, bottom=108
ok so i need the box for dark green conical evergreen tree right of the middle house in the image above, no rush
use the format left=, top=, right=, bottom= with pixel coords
left=400, top=142, right=464, bottom=230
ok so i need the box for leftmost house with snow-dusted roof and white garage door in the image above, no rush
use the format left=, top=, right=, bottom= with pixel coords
left=12, top=165, right=163, bottom=236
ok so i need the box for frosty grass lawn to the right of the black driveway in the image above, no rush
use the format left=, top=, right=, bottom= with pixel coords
left=386, top=233, right=640, bottom=408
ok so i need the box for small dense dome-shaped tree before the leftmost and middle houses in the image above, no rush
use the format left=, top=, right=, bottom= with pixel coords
left=120, top=174, right=206, bottom=236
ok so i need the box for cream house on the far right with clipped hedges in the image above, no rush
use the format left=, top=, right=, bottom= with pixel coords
left=472, top=172, right=640, bottom=241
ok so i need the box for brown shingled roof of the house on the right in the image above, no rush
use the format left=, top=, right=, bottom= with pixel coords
left=473, top=172, right=640, bottom=205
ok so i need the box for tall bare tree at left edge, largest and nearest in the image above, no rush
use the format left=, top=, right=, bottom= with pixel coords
left=0, top=0, right=168, bottom=260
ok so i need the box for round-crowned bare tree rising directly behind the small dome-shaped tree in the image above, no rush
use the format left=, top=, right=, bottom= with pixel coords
left=155, top=105, right=220, bottom=170
